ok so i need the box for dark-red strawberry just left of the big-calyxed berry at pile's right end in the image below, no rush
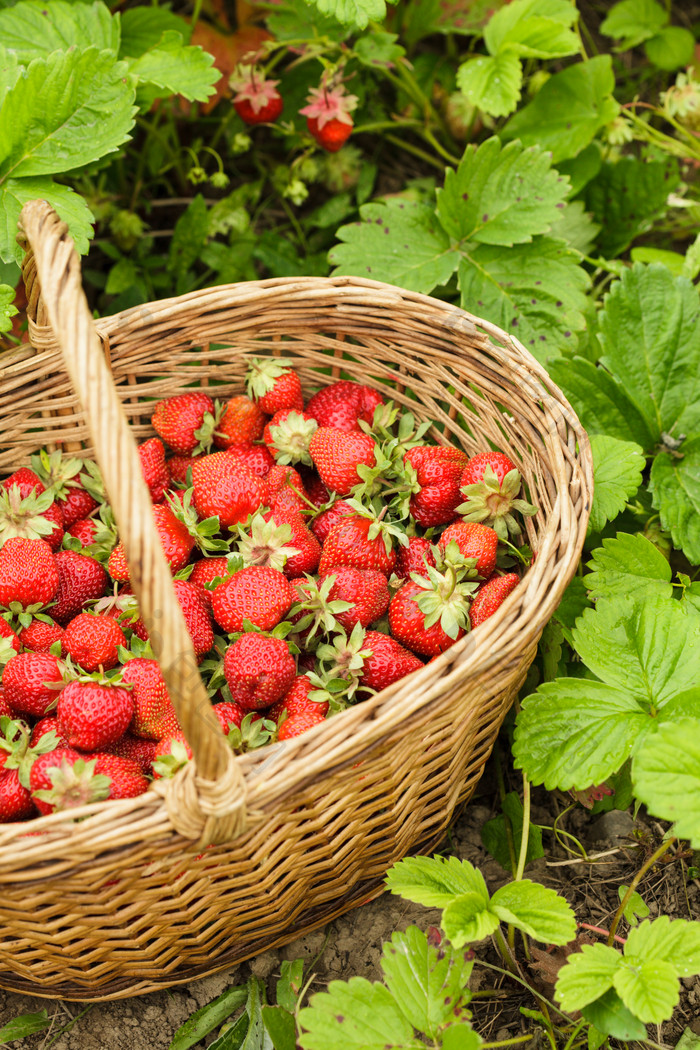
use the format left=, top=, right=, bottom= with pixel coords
left=403, top=445, right=469, bottom=528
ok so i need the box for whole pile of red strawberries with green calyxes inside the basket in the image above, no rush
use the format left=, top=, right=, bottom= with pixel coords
left=0, top=358, right=535, bottom=821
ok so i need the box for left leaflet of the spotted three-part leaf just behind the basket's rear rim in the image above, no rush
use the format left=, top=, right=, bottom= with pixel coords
left=328, top=198, right=459, bottom=292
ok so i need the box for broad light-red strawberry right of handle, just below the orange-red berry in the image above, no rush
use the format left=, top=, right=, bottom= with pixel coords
left=192, top=453, right=268, bottom=529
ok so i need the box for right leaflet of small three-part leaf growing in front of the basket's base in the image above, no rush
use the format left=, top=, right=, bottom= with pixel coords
left=490, top=879, right=576, bottom=944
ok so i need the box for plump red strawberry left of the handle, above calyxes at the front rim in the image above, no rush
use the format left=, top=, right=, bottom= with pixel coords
left=57, top=681, right=133, bottom=751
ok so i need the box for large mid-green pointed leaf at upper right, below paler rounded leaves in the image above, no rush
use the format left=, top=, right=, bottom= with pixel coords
left=502, top=55, right=619, bottom=164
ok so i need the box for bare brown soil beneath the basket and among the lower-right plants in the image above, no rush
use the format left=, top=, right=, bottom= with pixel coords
left=0, top=765, right=700, bottom=1050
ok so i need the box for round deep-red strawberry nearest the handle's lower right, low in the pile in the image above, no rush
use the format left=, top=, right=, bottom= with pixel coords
left=224, top=634, right=297, bottom=711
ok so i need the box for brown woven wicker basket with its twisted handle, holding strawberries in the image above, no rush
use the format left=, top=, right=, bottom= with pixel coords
left=0, top=202, right=592, bottom=1000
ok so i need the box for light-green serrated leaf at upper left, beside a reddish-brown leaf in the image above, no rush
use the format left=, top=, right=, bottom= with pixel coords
left=129, top=29, right=221, bottom=102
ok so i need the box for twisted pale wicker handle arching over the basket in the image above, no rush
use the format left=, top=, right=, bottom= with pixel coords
left=19, top=201, right=246, bottom=846
